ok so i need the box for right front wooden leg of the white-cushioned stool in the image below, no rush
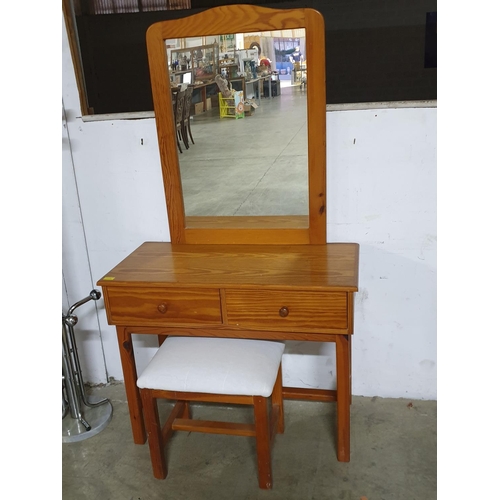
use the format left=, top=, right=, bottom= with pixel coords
left=253, top=396, right=273, bottom=490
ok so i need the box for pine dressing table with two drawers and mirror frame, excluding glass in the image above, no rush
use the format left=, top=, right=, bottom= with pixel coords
left=97, top=5, right=359, bottom=462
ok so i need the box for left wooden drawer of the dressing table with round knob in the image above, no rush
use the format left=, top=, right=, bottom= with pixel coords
left=106, top=287, right=222, bottom=326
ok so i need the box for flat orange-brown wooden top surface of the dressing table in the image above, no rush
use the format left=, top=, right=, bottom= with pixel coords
left=97, top=242, right=359, bottom=292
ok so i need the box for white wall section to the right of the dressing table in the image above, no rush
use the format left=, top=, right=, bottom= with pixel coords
left=327, top=108, right=437, bottom=399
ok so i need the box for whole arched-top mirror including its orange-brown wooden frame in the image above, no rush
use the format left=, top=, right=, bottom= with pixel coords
left=147, top=5, right=326, bottom=244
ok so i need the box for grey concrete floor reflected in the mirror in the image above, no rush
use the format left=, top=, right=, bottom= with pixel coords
left=179, top=82, right=308, bottom=216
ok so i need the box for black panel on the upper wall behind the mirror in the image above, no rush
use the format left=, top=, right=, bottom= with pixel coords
left=77, top=0, right=437, bottom=114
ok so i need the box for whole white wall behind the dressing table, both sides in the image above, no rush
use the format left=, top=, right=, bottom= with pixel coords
left=62, top=14, right=436, bottom=399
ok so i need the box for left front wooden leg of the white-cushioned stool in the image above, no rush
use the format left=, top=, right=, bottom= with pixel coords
left=141, top=389, right=167, bottom=479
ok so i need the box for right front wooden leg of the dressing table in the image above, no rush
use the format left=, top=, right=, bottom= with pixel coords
left=335, top=335, right=351, bottom=462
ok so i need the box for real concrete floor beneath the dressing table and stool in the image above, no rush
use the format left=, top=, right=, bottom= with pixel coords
left=62, top=384, right=437, bottom=500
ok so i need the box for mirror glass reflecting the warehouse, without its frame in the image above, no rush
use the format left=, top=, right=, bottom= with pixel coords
left=165, top=28, right=309, bottom=217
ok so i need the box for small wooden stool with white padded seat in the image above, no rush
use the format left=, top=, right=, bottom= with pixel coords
left=137, top=337, right=285, bottom=489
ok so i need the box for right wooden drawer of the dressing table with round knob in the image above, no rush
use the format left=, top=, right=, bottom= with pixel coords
left=225, top=290, right=348, bottom=333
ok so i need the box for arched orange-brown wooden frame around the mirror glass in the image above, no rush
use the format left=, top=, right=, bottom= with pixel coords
left=146, top=5, right=326, bottom=244
